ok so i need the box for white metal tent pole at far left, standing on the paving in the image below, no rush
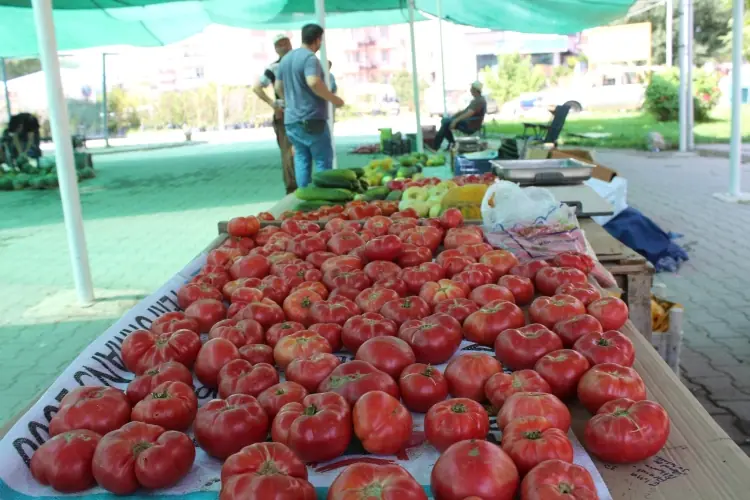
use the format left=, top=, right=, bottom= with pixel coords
left=31, top=0, right=94, bottom=305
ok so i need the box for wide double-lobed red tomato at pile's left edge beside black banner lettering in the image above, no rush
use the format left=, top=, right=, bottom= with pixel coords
left=121, top=330, right=201, bottom=375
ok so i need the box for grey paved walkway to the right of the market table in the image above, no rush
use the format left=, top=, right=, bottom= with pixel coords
left=596, top=152, right=750, bottom=454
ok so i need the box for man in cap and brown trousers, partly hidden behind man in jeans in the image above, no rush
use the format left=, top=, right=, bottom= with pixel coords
left=253, top=34, right=297, bottom=194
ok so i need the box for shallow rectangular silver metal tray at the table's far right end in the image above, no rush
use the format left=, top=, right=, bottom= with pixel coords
left=490, top=158, right=594, bottom=186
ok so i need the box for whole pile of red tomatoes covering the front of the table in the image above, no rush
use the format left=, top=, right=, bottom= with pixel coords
left=31, top=206, right=669, bottom=500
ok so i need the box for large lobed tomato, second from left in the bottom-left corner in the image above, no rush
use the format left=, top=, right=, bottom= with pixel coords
left=92, top=422, right=195, bottom=495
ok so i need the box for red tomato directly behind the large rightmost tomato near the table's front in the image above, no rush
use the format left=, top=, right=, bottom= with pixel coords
left=578, top=363, right=646, bottom=414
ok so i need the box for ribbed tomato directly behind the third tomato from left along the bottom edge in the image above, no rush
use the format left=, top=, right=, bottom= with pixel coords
left=424, top=398, right=490, bottom=453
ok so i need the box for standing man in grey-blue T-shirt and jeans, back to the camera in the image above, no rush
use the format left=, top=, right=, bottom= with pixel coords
left=274, top=24, right=344, bottom=187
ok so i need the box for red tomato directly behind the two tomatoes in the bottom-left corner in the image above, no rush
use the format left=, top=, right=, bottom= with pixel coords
left=49, top=387, right=130, bottom=436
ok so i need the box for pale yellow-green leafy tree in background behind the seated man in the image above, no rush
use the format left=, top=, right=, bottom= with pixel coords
left=483, top=54, right=546, bottom=104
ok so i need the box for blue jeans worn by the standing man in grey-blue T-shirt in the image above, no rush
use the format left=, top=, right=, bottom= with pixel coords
left=286, top=122, right=333, bottom=187
